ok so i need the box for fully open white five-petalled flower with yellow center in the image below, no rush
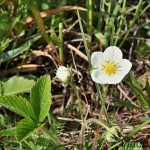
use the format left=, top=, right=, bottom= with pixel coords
left=91, top=46, right=132, bottom=84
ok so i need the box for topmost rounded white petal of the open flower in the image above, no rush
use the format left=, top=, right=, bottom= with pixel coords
left=103, top=46, right=122, bottom=62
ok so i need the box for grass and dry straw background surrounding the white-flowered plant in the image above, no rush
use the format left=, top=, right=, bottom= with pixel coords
left=0, top=0, right=150, bottom=150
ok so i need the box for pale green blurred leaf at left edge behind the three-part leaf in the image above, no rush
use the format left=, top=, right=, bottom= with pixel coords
left=0, top=76, right=35, bottom=96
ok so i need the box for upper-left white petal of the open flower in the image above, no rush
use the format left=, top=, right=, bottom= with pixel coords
left=91, top=52, right=103, bottom=68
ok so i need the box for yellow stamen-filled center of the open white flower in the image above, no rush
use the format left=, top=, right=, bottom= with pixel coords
left=102, top=60, right=119, bottom=76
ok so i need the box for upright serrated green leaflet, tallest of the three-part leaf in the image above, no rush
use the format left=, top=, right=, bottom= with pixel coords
left=30, top=75, right=51, bottom=122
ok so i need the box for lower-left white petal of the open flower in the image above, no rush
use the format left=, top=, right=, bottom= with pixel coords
left=91, top=69, right=106, bottom=84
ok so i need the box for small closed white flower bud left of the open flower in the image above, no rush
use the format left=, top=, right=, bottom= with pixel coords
left=56, top=66, right=71, bottom=83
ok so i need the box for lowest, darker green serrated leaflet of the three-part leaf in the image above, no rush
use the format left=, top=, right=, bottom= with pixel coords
left=16, top=119, right=44, bottom=142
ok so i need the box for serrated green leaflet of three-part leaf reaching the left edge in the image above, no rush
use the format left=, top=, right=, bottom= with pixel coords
left=0, top=95, right=35, bottom=119
